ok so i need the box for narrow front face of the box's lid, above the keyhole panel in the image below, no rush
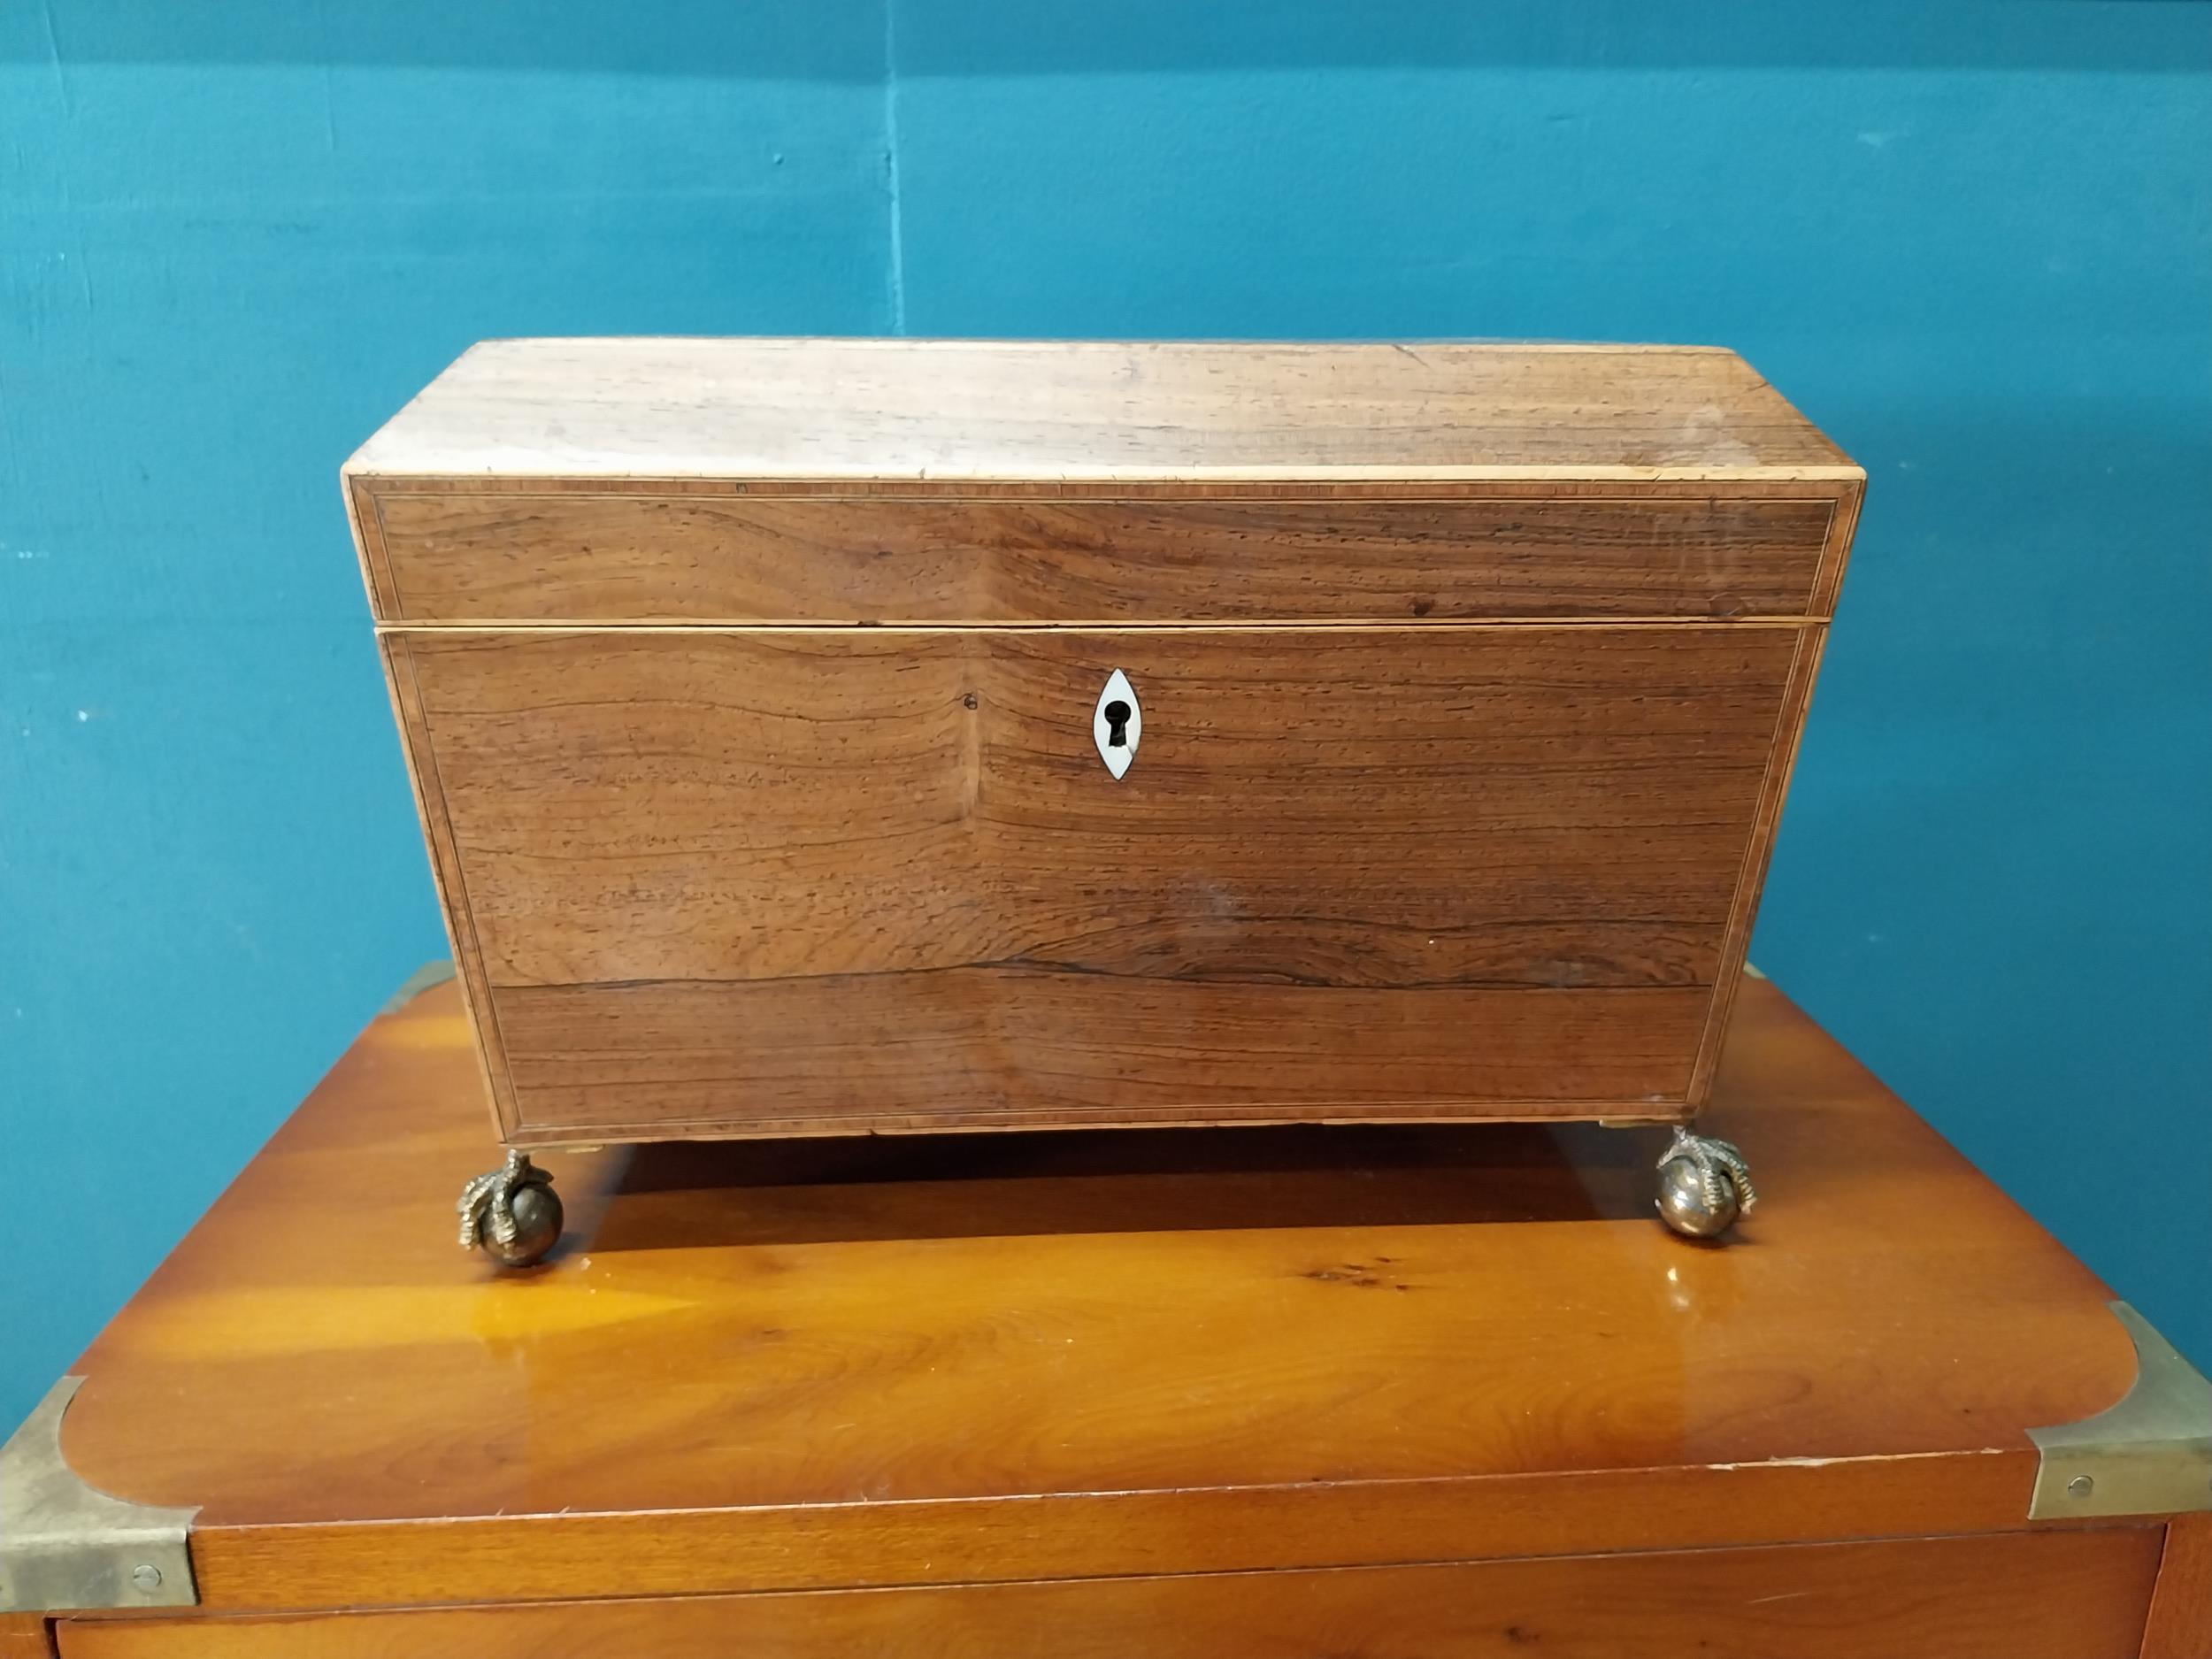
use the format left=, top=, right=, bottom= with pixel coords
left=357, top=485, right=1839, bottom=624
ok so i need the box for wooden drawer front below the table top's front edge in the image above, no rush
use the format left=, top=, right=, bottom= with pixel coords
left=60, top=1526, right=2162, bottom=1659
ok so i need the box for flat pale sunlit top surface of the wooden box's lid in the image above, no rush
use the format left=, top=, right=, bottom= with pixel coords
left=348, top=339, right=1863, bottom=482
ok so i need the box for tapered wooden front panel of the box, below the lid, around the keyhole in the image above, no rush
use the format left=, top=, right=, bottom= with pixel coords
left=392, top=626, right=1801, bottom=1141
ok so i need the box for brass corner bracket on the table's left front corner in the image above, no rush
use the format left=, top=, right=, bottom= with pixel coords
left=0, top=1376, right=199, bottom=1613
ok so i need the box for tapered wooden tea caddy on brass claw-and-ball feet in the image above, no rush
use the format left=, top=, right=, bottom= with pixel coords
left=345, top=339, right=1865, bottom=1263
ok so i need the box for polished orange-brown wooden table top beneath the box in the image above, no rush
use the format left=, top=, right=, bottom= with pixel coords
left=42, top=982, right=2135, bottom=1606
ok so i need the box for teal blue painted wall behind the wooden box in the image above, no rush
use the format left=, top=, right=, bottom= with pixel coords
left=0, top=0, right=2212, bottom=1420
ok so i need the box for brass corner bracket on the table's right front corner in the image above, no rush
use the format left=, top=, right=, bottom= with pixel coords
left=2029, top=1303, right=2212, bottom=1520
